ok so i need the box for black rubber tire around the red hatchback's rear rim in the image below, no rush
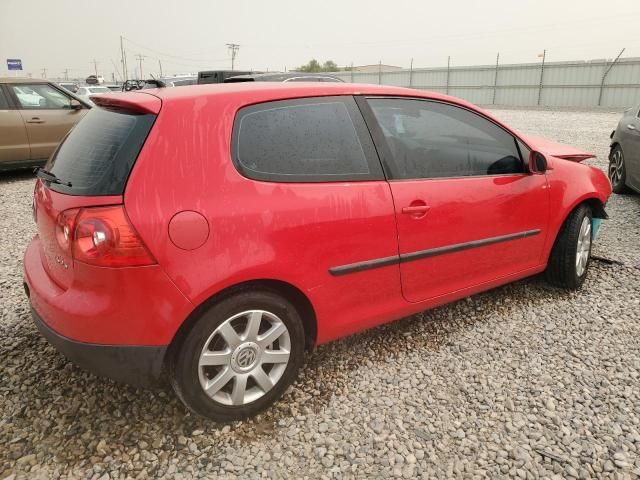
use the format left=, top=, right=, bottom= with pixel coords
left=167, top=291, right=305, bottom=422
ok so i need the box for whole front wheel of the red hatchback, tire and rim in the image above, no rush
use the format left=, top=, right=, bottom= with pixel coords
left=545, top=204, right=593, bottom=290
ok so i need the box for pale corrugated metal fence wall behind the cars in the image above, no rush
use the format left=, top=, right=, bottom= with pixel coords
left=335, top=58, right=640, bottom=107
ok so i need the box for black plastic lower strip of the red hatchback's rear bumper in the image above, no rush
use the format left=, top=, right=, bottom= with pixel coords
left=31, top=308, right=167, bottom=386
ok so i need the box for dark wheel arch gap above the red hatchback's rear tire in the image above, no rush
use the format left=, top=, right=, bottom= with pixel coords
left=164, top=279, right=318, bottom=363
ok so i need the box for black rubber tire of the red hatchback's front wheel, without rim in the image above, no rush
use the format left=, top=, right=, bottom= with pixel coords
left=545, top=204, right=593, bottom=290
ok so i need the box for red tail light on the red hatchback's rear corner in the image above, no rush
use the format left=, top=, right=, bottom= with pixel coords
left=56, top=205, right=156, bottom=267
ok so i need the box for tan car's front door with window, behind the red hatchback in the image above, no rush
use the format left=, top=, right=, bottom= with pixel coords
left=10, top=83, right=87, bottom=160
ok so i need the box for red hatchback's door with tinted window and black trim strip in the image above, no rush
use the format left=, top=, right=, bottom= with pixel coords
left=360, top=98, right=549, bottom=302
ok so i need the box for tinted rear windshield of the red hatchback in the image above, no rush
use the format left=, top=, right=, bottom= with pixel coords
left=45, top=108, right=155, bottom=196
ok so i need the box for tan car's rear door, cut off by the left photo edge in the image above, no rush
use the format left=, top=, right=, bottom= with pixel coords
left=0, top=85, right=31, bottom=168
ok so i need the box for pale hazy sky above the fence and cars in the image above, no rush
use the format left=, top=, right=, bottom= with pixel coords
left=0, top=0, right=640, bottom=79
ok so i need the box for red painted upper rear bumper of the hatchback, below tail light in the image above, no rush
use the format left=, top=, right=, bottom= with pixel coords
left=24, top=236, right=193, bottom=347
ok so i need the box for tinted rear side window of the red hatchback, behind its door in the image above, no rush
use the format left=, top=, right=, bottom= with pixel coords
left=232, top=97, right=383, bottom=182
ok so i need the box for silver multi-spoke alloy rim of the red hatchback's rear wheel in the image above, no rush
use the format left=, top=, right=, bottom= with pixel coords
left=198, top=310, right=291, bottom=406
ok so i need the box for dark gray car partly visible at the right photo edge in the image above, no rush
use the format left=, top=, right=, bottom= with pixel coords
left=608, top=107, right=640, bottom=193
